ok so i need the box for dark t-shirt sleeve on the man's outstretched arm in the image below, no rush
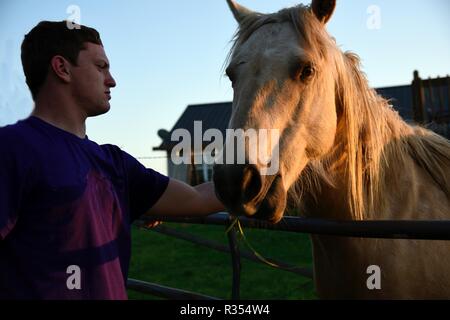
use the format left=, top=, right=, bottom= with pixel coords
left=123, top=152, right=169, bottom=222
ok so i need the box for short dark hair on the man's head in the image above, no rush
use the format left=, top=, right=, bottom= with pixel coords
left=21, top=21, right=103, bottom=100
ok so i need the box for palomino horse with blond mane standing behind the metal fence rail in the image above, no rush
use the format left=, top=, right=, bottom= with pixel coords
left=214, top=0, right=450, bottom=299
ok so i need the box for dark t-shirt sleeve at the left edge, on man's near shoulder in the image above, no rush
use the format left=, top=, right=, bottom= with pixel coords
left=0, top=128, right=28, bottom=240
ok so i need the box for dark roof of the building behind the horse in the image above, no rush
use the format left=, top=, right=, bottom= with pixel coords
left=153, top=85, right=413, bottom=150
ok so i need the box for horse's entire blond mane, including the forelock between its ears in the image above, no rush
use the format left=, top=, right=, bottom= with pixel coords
left=230, top=5, right=450, bottom=220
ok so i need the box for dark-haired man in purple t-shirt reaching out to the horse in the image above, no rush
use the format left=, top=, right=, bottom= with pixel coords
left=0, top=21, right=224, bottom=299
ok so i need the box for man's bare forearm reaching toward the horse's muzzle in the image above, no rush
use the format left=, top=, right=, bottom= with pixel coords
left=147, top=179, right=225, bottom=217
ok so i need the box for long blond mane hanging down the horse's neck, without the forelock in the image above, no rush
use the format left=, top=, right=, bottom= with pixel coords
left=326, top=52, right=450, bottom=220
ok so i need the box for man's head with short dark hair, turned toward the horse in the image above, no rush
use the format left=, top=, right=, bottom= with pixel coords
left=21, top=21, right=116, bottom=116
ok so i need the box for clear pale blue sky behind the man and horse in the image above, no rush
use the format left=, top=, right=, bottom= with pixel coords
left=0, top=0, right=450, bottom=173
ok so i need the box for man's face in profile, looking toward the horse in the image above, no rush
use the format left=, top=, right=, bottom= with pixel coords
left=71, top=42, right=116, bottom=117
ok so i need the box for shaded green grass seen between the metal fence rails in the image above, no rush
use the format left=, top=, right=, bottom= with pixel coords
left=128, top=223, right=316, bottom=300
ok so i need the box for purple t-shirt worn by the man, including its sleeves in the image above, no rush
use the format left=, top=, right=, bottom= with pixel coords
left=0, top=117, right=169, bottom=299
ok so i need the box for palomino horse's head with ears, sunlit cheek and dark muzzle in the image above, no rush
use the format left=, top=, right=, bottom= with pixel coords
left=214, top=0, right=339, bottom=222
